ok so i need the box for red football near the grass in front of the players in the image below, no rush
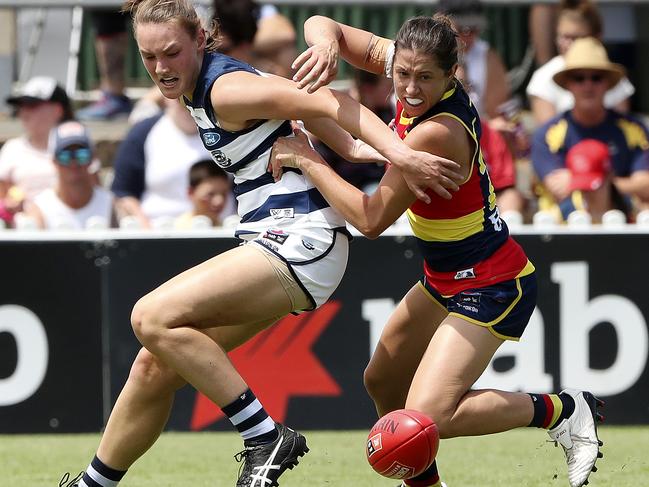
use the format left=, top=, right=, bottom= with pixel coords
left=367, top=409, right=439, bottom=480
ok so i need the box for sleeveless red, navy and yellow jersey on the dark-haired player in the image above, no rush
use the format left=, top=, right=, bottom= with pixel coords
left=394, top=82, right=534, bottom=296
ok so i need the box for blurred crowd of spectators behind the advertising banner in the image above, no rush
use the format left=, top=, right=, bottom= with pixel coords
left=0, top=0, right=649, bottom=233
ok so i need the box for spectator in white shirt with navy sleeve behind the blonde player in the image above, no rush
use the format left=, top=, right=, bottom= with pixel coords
left=111, top=98, right=215, bottom=228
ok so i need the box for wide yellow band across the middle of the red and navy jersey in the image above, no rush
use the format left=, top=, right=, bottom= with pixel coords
left=406, top=208, right=484, bottom=242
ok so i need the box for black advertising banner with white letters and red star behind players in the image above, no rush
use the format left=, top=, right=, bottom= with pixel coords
left=0, top=234, right=649, bottom=433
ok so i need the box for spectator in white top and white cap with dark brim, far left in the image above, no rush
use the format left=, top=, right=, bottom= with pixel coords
left=0, top=76, right=73, bottom=227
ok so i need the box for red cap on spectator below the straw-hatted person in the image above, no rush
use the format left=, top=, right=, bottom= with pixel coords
left=566, top=139, right=611, bottom=191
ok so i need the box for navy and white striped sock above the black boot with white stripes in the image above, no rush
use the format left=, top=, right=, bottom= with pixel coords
left=221, top=389, right=278, bottom=446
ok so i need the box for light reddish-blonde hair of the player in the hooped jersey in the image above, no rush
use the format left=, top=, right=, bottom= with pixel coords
left=121, top=0, right=219, bottom=51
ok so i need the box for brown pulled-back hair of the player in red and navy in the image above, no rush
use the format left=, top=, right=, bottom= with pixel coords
left=394, top=14, right=458, bottom=72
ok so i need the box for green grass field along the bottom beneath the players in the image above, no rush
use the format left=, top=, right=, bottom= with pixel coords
left=0, top=427, right=649, bottom=487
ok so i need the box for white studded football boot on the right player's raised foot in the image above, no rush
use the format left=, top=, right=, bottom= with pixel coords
left=548, top=389, right=604, bottom=487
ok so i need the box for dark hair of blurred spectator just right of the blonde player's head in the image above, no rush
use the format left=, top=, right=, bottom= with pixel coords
left=214, top=0, right=259, bottom=46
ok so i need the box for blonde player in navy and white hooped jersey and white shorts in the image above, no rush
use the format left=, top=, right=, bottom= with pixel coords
left=59, top=0, right=460, bottom=487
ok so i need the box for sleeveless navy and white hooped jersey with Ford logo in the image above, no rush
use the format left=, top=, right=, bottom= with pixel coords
left=183, top=52, right=345, bottom=239
